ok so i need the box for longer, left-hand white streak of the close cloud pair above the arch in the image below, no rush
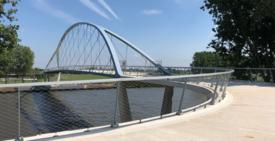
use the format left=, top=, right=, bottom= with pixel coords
left=80, top=0, right=111, bottom=20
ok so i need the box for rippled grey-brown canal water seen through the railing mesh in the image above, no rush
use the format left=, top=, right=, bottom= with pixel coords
left=0, top=88, right=207, bottom=140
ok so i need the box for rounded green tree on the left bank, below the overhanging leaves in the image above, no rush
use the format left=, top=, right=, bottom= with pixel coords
left=10, top=46, right=34, bottom=75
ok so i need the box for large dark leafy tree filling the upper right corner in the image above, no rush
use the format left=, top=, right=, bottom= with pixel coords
left=202, top=0, right=275, bottom=79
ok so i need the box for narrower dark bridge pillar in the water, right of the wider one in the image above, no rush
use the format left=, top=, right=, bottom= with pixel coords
left=161, top=86, right=174, bottom=115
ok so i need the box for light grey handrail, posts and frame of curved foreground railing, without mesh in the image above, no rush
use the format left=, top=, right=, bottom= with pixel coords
left=0, top=69, right=234, bottom=140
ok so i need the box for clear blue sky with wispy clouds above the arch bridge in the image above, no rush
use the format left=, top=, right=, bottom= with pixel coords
left=17, top=0, right=213, bottom=68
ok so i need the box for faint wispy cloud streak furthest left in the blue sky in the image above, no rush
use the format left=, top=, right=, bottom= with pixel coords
left=34, top=0, right=79, bottom=23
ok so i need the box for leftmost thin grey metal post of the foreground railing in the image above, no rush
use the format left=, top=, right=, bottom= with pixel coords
left=15, top=87, right=23, bottom=141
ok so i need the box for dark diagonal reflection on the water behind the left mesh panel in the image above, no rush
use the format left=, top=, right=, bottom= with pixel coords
left=30, top=87, right=92, bottom=132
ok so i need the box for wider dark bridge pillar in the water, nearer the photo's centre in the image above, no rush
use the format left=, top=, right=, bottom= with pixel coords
left=112, top=82, right=132, bottom=127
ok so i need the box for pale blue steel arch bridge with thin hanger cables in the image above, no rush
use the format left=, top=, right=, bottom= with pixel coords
left=45, top=22, right=169, bottom=77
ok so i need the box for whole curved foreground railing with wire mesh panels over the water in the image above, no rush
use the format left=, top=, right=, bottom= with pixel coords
left=0, top=70, right=233, bottom=140
